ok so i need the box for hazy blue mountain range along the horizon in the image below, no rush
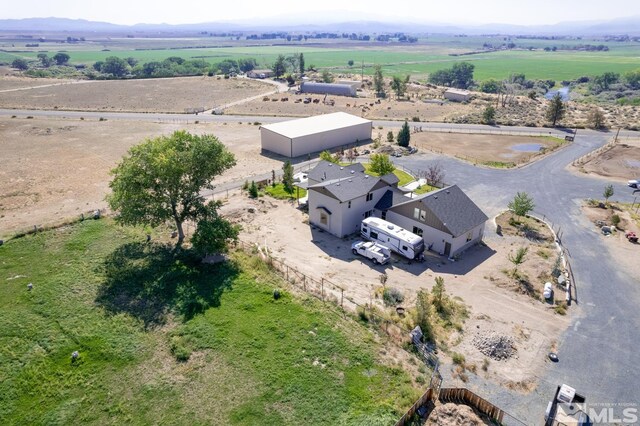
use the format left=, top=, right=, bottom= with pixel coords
left=0, top=14, right=640, bottom=36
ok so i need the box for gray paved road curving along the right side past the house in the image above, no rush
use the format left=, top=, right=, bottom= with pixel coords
left=395, top=131, right=640, bottom=424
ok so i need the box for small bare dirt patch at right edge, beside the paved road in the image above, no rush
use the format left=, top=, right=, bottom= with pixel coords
left=571, top=139, right=640, bottom=182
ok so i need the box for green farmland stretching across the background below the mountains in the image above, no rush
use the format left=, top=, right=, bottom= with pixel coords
left=0, top=36, right=640, bottom=81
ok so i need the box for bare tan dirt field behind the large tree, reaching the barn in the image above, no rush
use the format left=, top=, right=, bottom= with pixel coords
left=0, top=118, right=281, bottom=237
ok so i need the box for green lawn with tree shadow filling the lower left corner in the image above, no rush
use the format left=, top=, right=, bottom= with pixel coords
left=0, top=219, right=419, bottom=425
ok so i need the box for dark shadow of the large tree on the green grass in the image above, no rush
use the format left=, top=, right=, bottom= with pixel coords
left=95, top=243, right=239, bottom=328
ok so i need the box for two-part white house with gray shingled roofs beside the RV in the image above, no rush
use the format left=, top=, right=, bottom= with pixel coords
left=308, top=161, right=488, bottom=256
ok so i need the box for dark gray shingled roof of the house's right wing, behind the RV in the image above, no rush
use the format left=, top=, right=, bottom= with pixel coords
left=392, top=185, right=489, bottom=237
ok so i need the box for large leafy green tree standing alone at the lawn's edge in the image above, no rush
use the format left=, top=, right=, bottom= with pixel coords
left=107, top=131, right=236, bottom=246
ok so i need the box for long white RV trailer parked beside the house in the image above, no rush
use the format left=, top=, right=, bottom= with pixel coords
left=360, top=217, right=424, bottom=259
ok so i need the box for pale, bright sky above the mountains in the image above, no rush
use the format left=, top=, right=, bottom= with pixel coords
left=0, top=0, right=640, bottom=25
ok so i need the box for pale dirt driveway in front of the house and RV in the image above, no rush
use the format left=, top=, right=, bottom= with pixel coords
left=223, top=195, right=569, bottom=390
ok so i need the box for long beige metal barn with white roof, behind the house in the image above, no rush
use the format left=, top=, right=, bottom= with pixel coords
left=260, top=112, right=373, bottom=157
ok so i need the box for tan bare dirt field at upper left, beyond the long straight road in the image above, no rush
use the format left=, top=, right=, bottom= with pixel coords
left=2, top=77, right=274, bottom=113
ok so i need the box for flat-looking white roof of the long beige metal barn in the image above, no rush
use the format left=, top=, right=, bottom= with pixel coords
left=261, top=112, right=371, bottom=139
